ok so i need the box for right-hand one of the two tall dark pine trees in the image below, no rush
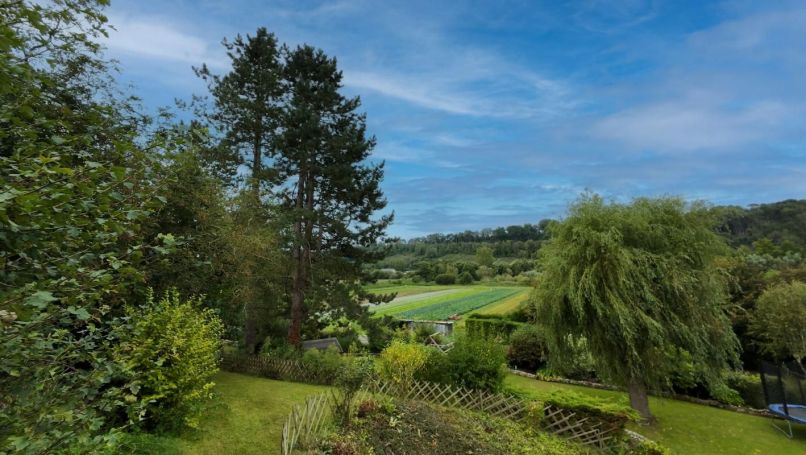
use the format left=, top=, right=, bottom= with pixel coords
left=275, top=46, right=392, bottom=344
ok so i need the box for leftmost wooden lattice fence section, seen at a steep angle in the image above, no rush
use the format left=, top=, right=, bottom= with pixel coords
left=280, top=393, right=331, bottom=455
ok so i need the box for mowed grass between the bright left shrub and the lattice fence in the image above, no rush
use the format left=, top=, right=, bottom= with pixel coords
left=121, top=372, right=327, bottom=455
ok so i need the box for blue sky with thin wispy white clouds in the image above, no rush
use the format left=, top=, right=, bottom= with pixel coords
left=107, top=0, right=806, bottom=237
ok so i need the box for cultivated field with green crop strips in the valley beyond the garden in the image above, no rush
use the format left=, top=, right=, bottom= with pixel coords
left=370, top=285, right=529, bottom=320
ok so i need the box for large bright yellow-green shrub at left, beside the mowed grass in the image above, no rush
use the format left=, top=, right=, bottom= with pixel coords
left=114, top=290, right=223, bottom=429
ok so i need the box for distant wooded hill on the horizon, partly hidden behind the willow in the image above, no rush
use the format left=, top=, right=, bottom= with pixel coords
left=377, top=199, right=806, bottom=270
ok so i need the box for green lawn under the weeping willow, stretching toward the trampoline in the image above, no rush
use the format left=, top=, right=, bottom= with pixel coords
left=506, top=375, right=806, bottom=455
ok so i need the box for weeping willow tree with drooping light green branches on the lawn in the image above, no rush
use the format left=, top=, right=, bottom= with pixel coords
left=533, top=195, right=738, bottom=422
